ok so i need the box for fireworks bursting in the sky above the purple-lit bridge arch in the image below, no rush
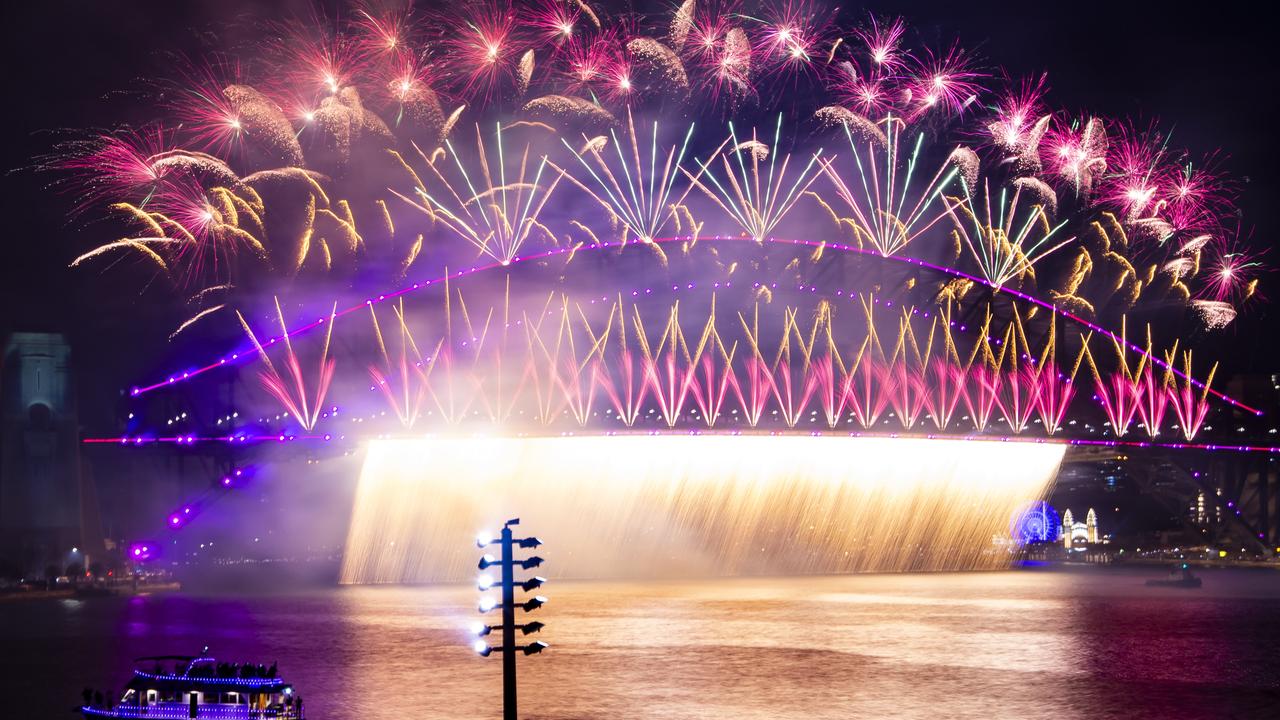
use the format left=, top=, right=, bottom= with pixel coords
left=65, top=0, right=1258, bottom=323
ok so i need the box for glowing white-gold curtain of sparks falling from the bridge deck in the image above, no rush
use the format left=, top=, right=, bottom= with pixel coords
left=340, top=434, right=1065, bottom=583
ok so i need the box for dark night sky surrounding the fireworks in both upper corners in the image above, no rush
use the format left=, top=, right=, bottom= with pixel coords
left=0, top=0, right=1280, bottom=430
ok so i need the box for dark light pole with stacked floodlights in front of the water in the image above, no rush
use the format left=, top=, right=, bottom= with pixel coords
left=474, top=518, right=549, bottom=720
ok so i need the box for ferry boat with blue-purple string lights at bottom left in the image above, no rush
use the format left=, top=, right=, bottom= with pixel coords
left=81, top=648, right=305, bottom=720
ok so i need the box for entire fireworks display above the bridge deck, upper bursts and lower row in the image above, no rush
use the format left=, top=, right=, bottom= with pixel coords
left=55, top=0, right=1262, bottom=442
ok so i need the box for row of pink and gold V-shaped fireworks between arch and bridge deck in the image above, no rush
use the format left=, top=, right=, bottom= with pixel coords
left=215, top=282, right=1210, bottom=442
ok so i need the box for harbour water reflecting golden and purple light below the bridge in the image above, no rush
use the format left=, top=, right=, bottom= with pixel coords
left=0, top=570, right=1280, bottom=720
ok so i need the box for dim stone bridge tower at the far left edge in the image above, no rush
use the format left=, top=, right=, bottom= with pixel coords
left=0, top=333, right=101, bottom=577
